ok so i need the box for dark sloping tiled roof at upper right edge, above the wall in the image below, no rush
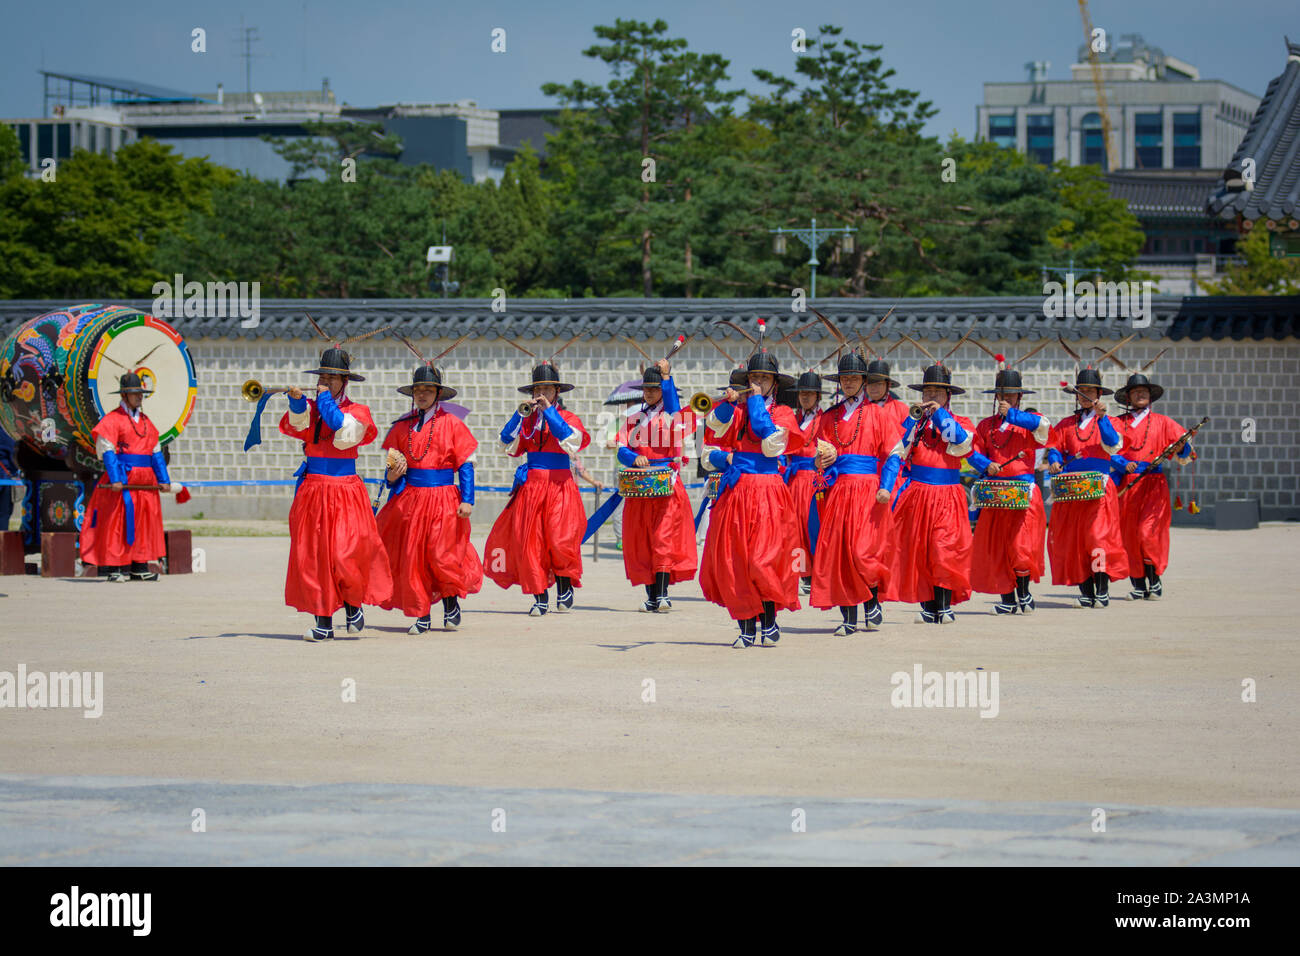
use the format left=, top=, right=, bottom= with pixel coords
left=1208, top=40, right=1300, bottom=220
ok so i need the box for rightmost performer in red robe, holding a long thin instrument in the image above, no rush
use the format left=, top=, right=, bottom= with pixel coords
left=1110, top=372, right=1196, bottom=601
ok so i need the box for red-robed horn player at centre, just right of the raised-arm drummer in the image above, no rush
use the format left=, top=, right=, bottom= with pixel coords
left=699, top=349, right=800, bottom=648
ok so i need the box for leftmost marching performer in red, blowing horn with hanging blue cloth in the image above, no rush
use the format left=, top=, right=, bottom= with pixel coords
left=280, top=349, right=393, bottom=641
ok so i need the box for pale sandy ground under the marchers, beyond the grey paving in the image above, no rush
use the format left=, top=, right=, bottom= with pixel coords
left=0, top=524, right=1300, bottom=808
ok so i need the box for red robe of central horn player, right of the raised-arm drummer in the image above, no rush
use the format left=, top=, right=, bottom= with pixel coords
left=699, top=403, right=809, bottom=620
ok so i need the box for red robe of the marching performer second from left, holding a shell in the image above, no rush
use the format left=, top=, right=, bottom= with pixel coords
left=376, top=410, right=484, bottom=618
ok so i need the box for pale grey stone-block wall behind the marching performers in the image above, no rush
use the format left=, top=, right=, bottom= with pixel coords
left=154, top=338, right=1300, bottom=524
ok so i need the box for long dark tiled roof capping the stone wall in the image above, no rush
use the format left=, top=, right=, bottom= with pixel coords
left=0, top=295, right=1300, bottom=351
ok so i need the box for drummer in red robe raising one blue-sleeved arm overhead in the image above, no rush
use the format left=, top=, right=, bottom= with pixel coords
left=618, top=359, right=698, bottom=613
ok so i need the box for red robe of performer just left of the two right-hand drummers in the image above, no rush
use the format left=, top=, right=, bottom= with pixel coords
left=889, top=415, right=975, bottom=606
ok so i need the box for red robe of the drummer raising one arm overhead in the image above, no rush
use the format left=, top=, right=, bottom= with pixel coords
left=619, top=395, right=698, bottom=584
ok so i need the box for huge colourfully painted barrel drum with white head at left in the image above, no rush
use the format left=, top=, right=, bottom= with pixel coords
left=0, top=304, right=198, bottom=470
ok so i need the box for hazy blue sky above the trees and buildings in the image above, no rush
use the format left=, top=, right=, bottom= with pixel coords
left=0, top=0, right=1300, bottom=137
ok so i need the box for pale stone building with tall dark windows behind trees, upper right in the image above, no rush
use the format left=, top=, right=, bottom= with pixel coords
left=975, top=34, right=1260, bottom=170
